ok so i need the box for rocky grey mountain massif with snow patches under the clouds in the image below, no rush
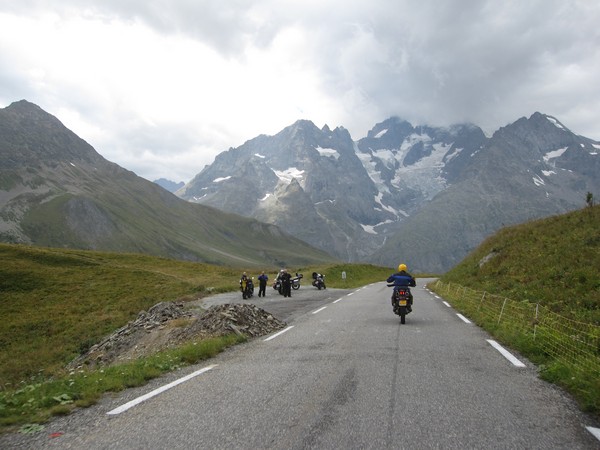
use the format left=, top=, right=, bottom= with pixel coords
left=177, top=113, right=600, bottom=271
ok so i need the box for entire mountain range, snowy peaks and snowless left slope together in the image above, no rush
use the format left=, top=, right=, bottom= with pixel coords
left=0, top=100, right=600, bottom=273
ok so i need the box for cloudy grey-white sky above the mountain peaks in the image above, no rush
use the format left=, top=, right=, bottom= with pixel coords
left=0, top=0, right=600, bottom=181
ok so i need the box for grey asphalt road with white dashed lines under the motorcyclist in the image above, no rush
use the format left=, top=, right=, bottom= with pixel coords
left=0, top=280, right=600, bottom=449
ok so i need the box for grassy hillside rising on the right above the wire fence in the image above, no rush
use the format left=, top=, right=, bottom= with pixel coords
left=442, top=206, right=600, bottom=325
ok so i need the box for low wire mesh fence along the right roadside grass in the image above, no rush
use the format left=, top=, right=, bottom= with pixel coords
left=432, top=280, right=600, bottom=377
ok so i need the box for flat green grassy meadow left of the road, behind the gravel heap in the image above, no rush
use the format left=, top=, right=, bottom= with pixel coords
left=0, top=244, right=391, bottom=391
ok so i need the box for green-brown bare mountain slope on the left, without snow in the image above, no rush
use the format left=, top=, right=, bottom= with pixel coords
left=0, top=100, right=334, bottom=267
